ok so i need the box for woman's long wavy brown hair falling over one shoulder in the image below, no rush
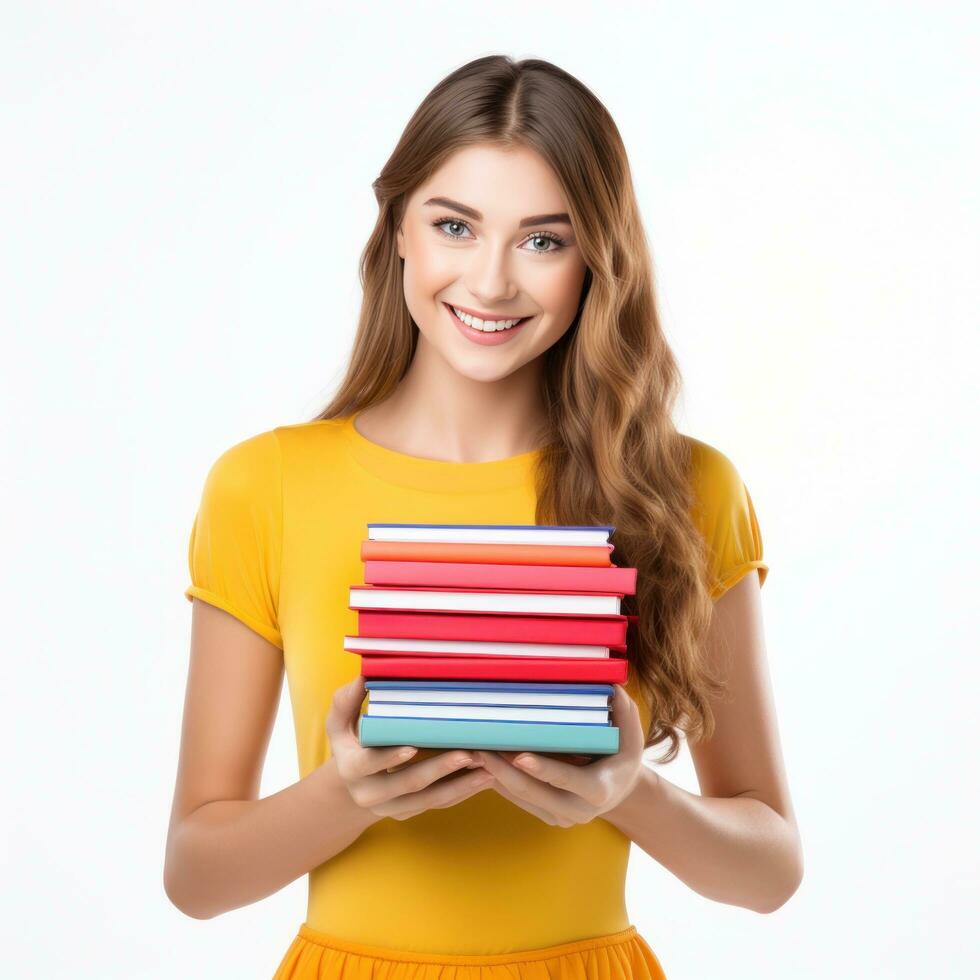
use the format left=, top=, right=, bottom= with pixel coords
left=316, top=55, right=723, bottom=762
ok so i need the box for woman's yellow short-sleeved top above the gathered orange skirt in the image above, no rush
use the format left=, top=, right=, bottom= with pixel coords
left=185, top=417, right=768, bottom=954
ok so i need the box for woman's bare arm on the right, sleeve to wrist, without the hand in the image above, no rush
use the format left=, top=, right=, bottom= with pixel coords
left=604, top=573, right=803, bottom=912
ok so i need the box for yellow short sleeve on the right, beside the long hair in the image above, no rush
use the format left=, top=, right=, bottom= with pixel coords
left=691, top=439, right=769, bottom=600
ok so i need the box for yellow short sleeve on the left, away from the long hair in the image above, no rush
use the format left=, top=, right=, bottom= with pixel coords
left=184, top=430, right=283, bottom=649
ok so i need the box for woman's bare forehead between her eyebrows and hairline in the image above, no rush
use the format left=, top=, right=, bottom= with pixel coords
left=409, top=144, right=568, bottom=222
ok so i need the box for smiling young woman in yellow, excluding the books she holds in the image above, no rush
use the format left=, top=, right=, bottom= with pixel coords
left=165, top=56, right=802, bottom=980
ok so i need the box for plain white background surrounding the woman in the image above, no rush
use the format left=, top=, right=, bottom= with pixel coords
left=0, top=2, right=980, bottom=980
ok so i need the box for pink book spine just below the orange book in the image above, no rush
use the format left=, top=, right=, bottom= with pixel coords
left=364, top=560, right=636, bottom=595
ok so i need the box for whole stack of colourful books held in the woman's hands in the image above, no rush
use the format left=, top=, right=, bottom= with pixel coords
left=344, top=524, right=636, bottom=763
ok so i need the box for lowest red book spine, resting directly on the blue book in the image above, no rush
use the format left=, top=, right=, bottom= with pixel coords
left=356, top=653, right=628, bottom=684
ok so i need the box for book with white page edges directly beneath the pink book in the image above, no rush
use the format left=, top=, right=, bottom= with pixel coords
left=349, top=585, right=622, bottom=616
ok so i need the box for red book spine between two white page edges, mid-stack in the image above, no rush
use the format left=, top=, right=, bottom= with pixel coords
left=357, top=609, right=629, bottom=651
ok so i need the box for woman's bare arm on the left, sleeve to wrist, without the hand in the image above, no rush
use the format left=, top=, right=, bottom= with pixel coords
left=164, top=599, right=379, bottom=919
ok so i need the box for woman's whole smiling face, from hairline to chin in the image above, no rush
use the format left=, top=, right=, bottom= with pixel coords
left=398, top=145, right=586, bottom=381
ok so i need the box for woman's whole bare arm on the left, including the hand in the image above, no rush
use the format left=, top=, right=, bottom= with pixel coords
left=163, top=598, right=492, bottom=919
